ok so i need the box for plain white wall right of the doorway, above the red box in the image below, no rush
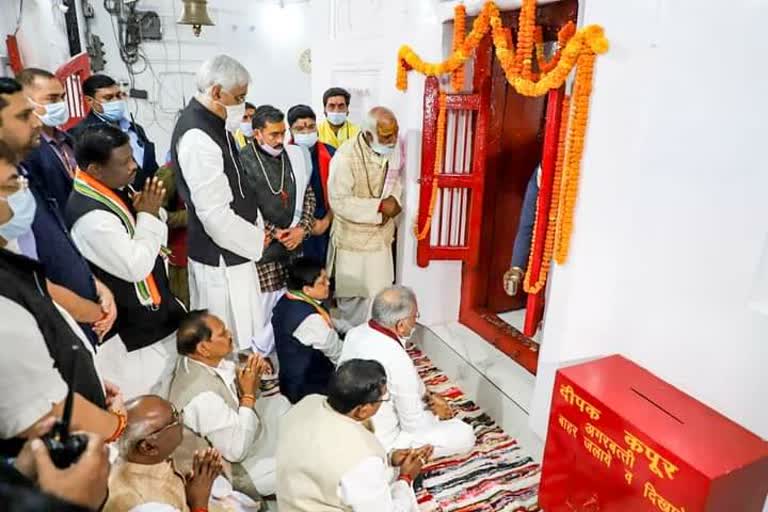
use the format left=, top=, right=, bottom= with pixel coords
left=531, top=0, right=768, bottom=448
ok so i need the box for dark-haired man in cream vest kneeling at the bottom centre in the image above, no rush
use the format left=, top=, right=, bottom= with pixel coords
left=277, top=359, right=432, bottom=512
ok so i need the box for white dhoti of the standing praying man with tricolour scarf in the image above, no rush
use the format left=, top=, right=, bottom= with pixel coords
left=94, top=332, right=178, bottom=400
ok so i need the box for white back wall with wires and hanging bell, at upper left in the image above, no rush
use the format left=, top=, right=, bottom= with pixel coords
left=86, top=0, right=311, bottom=159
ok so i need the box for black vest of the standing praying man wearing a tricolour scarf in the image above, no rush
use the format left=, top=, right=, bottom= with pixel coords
left=67, top=190, right=184, bottom=352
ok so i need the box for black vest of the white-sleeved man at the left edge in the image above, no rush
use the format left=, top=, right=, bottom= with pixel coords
left=0, top=249, right=106, bottom=416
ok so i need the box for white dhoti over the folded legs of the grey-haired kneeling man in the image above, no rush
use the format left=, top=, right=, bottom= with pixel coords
left=388, top=417, right=475, bottom=457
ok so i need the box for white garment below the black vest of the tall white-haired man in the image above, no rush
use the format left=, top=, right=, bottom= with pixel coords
left=188, top=259, right=267, bottom=350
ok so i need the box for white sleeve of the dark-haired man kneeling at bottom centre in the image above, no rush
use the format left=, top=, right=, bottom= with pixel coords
left=339, top=457, right=418, bottom=512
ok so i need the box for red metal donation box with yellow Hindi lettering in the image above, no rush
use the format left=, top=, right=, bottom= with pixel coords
left=539, top=355, right=768, bottom=512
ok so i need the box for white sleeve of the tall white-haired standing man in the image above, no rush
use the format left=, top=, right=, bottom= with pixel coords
left=178, top=129, right=264, bottom=261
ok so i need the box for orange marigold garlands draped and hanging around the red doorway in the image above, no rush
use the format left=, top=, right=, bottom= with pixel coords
left=396, top=0, right=608, bottom=272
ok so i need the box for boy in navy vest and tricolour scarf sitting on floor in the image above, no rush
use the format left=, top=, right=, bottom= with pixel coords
left=272, top=259, right=341, bottom=404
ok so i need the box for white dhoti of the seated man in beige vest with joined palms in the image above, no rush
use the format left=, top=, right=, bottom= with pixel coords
left=240, top=394, right=291, bottom=496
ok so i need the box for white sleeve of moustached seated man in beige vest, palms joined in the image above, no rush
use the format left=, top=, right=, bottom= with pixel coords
left=184, top=391, right=261, bottom=462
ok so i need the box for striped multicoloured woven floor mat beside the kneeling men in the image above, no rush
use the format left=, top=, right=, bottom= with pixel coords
left=408, top=348, right=541, bottom=512
